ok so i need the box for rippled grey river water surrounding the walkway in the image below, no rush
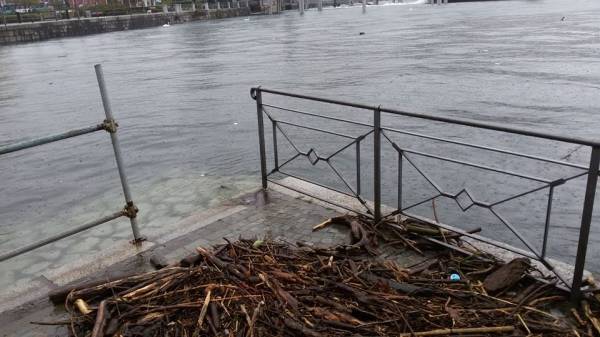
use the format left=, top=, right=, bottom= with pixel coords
left=0, top=0, right=600, bottom=284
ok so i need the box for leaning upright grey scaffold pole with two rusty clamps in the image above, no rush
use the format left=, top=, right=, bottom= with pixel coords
left=94, top=64, right=142, bottom=242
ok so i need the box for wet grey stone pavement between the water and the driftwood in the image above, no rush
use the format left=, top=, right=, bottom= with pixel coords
left=0, top=181, right=424, bottom=337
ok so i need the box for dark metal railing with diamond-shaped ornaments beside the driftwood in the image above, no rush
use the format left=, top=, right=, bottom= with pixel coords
left=250, top=87, right=600, bottom=300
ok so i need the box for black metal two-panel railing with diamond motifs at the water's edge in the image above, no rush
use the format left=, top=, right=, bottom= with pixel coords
left=251, top=87, right=600, bottom=299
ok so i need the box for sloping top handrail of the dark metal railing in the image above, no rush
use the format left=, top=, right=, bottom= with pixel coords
left=253, top=88, right=600, bottom=147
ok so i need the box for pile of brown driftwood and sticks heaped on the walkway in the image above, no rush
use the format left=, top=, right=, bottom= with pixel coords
left=54, top=217, right=600, bottom=337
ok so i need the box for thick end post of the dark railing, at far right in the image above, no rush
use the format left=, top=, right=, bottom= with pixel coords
left=571, top=146, right=600, bottom=302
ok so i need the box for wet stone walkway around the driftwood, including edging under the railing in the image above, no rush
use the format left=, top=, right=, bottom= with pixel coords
left=0, top=178, right=592, bottom=337
